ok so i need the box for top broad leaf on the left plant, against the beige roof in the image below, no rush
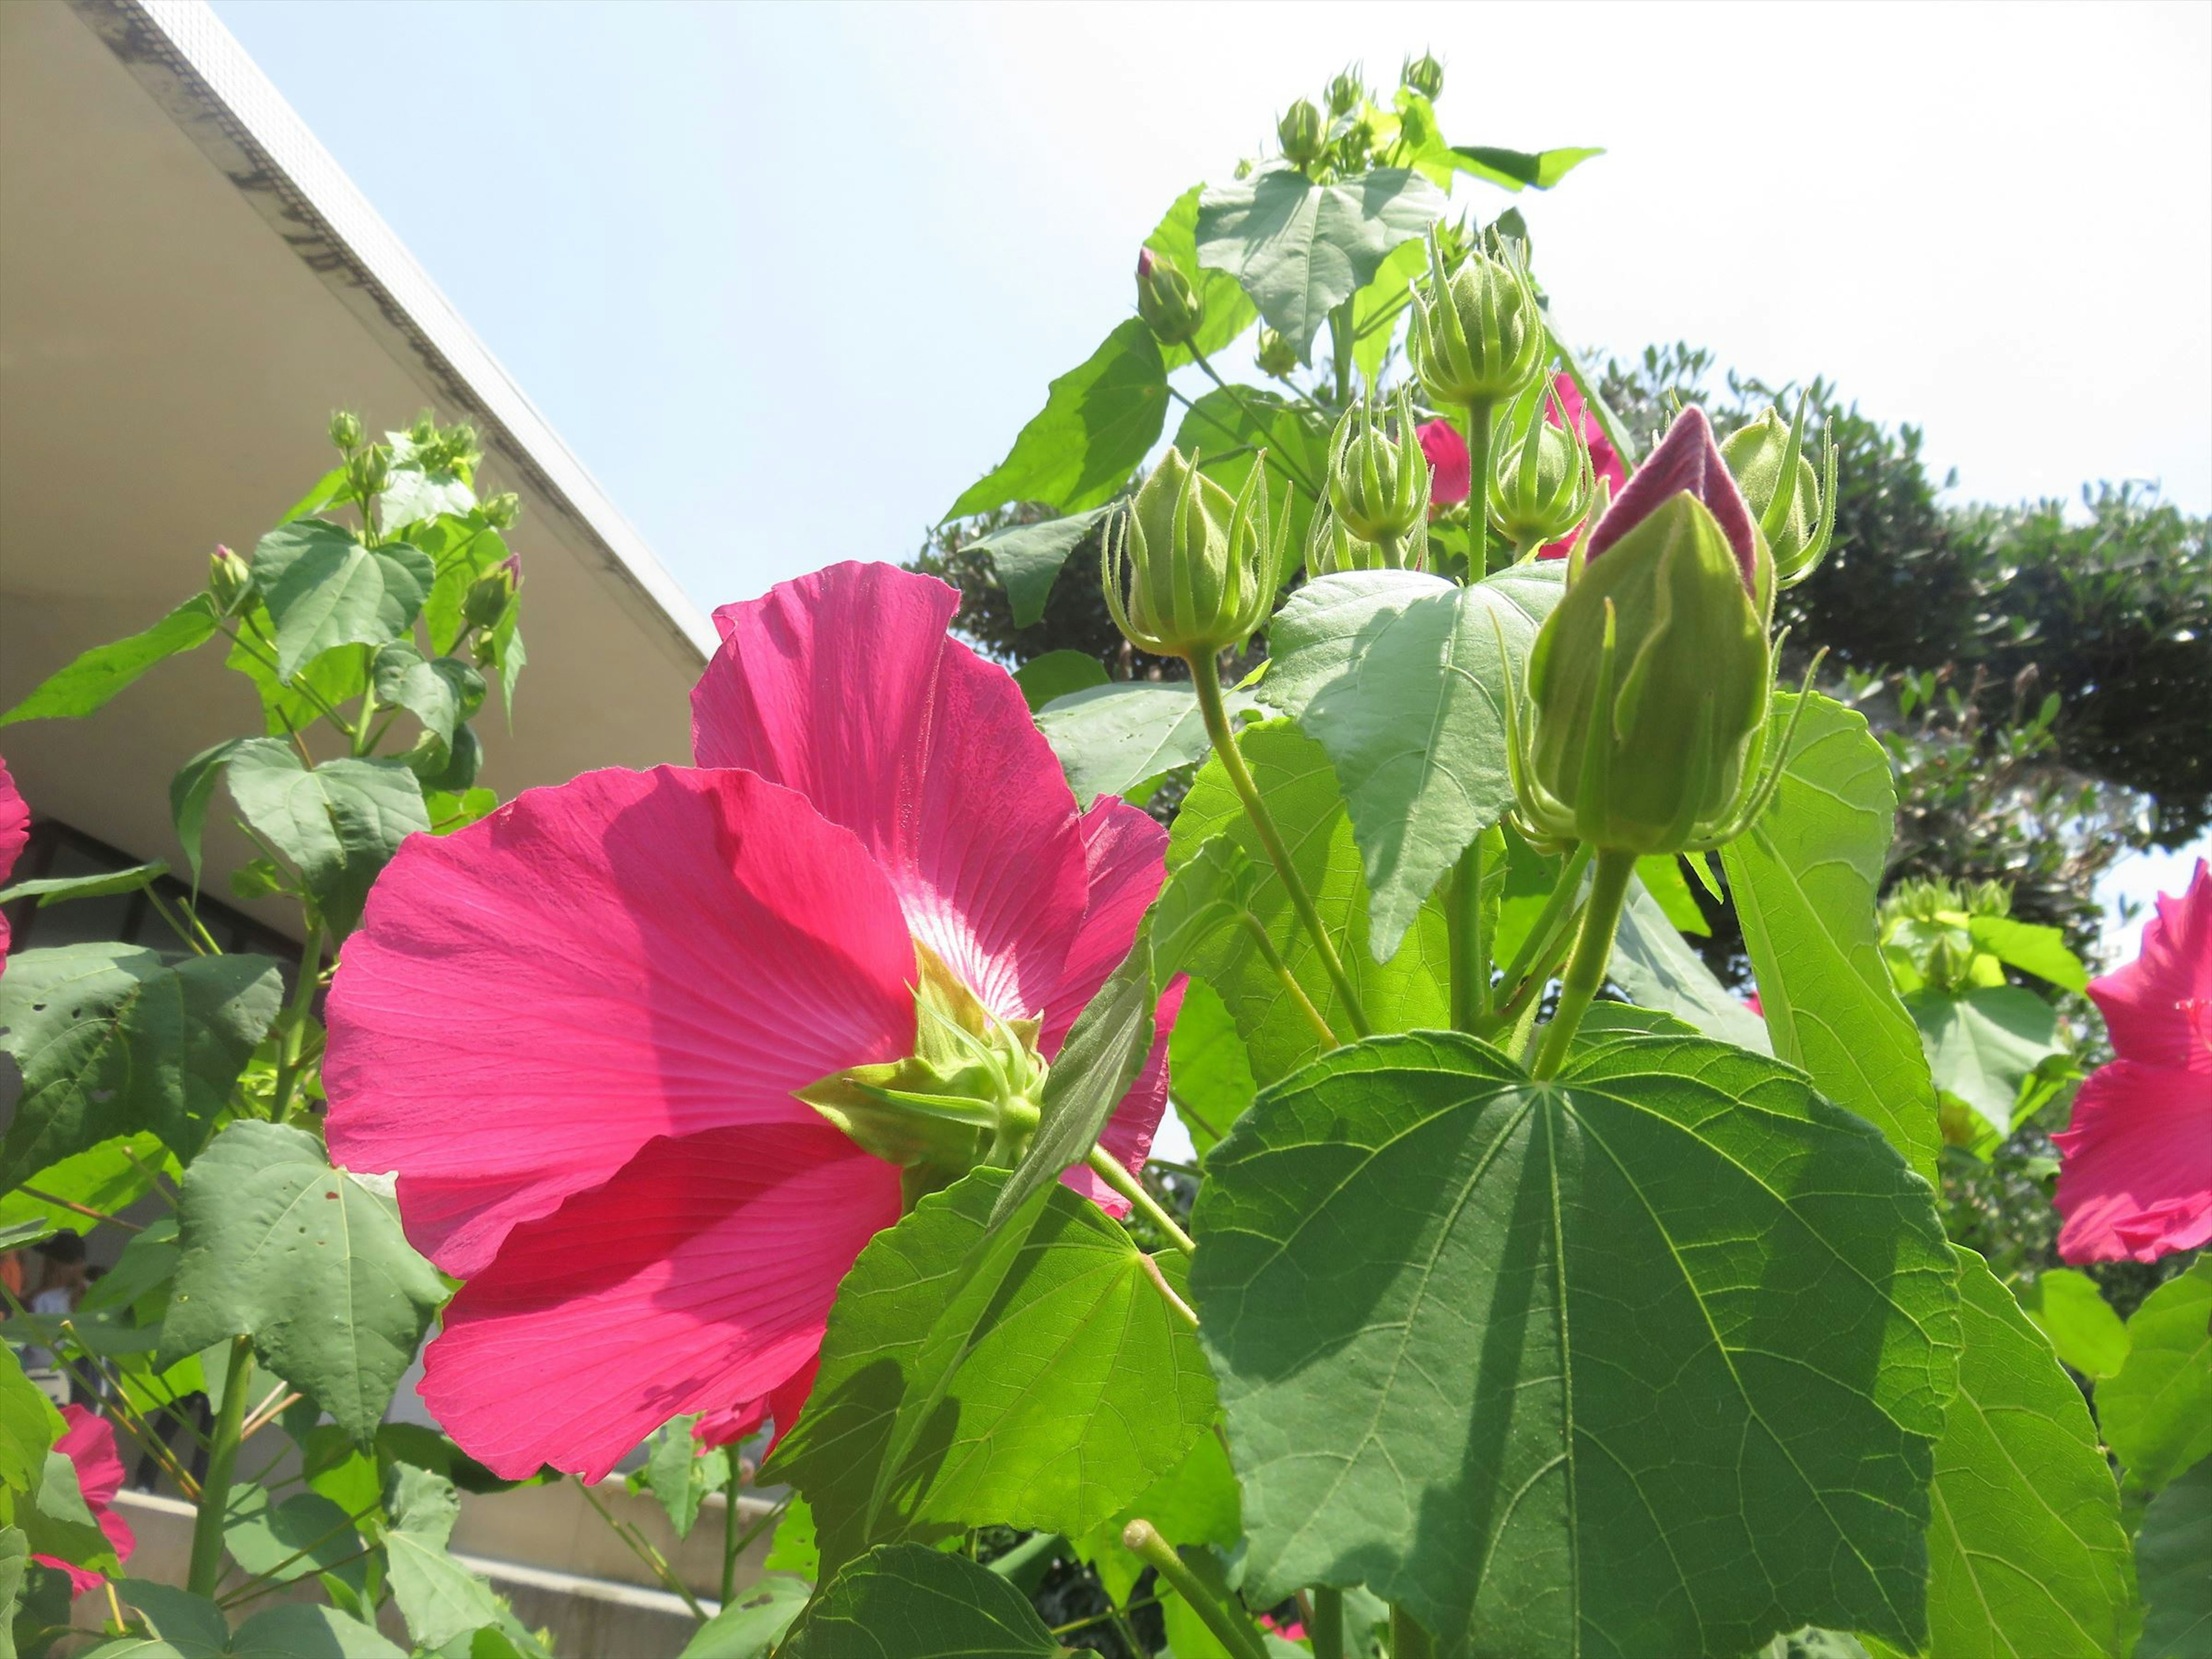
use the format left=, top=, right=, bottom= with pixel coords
left=255, top=518, right=438, bottom=679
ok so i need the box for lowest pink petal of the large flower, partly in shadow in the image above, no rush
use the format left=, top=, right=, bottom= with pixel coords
left=421, top=1122, right=898, bottom=1480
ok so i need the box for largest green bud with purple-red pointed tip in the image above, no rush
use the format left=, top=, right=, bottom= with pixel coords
left=1515, top=407, right=1772, bottom=854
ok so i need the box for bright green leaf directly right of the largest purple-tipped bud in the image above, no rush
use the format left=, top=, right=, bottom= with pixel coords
left=1721, top=692, right=1937, bottom=1181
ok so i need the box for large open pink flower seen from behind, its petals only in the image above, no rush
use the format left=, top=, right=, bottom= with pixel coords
left=325, top=564, right=1181, bottom=1480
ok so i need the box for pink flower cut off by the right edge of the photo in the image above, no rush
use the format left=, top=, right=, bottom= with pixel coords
left=2051, top=858, right=2212, bottom=1261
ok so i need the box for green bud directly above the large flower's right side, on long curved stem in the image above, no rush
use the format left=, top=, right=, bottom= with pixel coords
left=1099, top=447, right=1290, bottom=661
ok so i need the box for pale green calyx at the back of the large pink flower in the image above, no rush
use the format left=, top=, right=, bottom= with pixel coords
left=796, top=942, right=1051, bottom=1206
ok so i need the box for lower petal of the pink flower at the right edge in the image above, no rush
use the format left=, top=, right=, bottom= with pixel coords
left=2051, top=1059, right=2212, bottom=1261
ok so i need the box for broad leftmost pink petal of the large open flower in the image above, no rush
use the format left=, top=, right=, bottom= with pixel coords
left=323, top=767, right=914, bottom=1277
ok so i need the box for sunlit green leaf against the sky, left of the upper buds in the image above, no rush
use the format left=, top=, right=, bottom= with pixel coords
left=945, top=316, right=1168, bottom=518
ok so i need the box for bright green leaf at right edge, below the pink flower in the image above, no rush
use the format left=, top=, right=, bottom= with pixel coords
left=2097, top=1256, right=2212, bottom=1493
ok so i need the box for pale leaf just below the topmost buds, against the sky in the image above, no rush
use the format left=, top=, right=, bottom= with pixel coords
left=1196, top=168, right=1445, bottom=361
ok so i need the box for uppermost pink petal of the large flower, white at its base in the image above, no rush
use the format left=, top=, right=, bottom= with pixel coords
left=692, top=564, right=1084, bottom=1020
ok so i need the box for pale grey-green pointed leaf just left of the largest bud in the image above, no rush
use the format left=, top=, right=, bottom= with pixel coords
left=1259, top=562, right=1562, bottom=960
